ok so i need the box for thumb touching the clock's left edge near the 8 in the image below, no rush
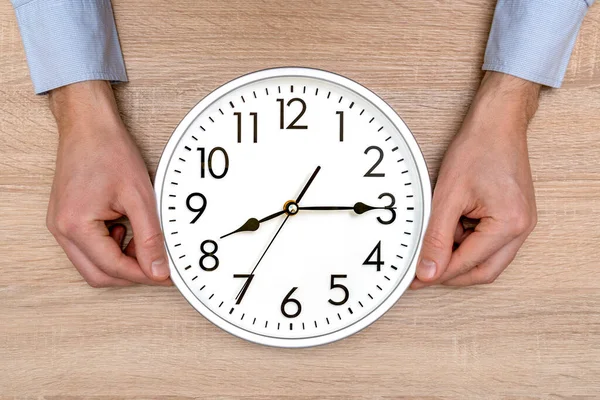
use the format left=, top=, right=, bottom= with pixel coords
left=123, top=188, right=170, bottom=281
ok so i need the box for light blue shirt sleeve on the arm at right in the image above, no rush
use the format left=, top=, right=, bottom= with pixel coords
left=483, top=0, right=593, bottom=88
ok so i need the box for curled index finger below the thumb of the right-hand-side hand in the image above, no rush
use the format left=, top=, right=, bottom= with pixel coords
left=438, top=218, right=514, bottom=282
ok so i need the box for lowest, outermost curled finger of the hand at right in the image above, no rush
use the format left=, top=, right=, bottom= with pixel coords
left=442, top=238, right=524, bottom=286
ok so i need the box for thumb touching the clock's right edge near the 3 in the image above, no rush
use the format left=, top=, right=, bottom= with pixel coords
left=417, top=190, right=463, bottom=282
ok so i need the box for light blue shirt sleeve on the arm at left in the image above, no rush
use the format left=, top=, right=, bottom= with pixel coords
left=12, top=0, right=127, bottom=94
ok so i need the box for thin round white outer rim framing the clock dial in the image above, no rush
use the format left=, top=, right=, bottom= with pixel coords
left=154, top=67, right=431, bottom=348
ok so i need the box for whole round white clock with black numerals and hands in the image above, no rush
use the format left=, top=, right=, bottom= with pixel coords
left=155, top=68, right=431, bottom=347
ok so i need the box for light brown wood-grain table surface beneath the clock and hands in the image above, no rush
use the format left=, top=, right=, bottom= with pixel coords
left=0, top=0, right=600, bottom=399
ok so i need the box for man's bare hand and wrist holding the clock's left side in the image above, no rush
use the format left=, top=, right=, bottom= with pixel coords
left=47, top=81, right=171, bottom=287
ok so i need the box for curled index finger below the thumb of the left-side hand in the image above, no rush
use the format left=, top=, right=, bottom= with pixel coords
left=69, top=221, right=171, bottom=285
